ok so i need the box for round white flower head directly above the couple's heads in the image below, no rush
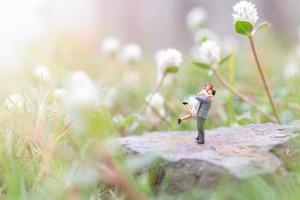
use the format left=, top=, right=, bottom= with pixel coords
left=198, top=40, right=221, bottom=65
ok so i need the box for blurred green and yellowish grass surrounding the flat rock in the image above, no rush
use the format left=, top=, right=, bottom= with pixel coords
left=0, top=30, right=300, bottom=200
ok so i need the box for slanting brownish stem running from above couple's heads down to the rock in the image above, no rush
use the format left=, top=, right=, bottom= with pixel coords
left=213, top=69, right=276, bottom=122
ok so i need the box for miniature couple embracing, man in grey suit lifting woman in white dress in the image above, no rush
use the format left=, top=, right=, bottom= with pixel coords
left=178, top=83, right=216, bottom=144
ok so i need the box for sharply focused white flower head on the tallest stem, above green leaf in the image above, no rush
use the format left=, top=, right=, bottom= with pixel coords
left=232, top=1, right=258, bottom=25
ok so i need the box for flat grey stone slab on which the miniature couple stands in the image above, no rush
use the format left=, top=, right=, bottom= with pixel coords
left=117, top=123, right=300, bottom=190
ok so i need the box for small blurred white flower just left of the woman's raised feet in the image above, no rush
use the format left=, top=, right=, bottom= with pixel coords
left=146, top=93, right=166, bottom=124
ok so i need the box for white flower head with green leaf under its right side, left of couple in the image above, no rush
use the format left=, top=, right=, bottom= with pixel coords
left=155, top=48, right=182, bottom=80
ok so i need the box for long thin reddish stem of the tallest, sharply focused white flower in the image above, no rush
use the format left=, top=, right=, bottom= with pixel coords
left=248, top=35, right=281, bottom=124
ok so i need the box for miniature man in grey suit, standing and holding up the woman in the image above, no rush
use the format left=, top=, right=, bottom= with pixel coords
left=195, top=89, right=216, bottom=144
